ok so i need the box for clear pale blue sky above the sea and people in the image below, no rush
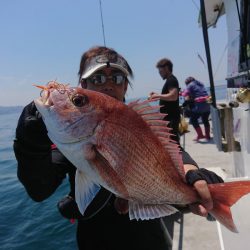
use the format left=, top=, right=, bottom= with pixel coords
left=0, top=0, right=227, bottom=106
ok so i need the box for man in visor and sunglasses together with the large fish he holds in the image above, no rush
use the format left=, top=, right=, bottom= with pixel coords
left=14, top=46, right=242, bottom=250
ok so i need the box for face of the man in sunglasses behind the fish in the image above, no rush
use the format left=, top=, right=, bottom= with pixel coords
left=82, top=67, right=128, bottom=101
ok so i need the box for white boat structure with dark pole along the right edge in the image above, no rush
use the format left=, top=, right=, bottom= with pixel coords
left=200, top=0, right=250, bottom=250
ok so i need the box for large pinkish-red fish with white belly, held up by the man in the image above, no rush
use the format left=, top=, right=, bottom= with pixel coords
left=35, top=84, right=250, bottom=232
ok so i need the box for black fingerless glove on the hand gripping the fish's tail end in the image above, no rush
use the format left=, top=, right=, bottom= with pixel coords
left=186, top=168, right=224, bottom=185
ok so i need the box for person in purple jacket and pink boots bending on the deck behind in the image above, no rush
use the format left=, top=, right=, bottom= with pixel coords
left=182, top=76, right=211, bottom=141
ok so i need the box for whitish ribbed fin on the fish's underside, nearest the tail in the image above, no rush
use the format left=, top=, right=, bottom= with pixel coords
left=129, top=201, right=178, bottom=220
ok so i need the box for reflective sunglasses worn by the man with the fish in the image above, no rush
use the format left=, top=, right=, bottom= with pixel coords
left=86, top=73, right=127, bottom=86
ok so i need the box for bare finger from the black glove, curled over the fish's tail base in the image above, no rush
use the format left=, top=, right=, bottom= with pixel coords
left=193, top=180, right=213, bottom=210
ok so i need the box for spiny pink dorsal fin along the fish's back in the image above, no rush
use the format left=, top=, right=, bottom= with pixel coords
left=128, top=100, right=185, bottom=179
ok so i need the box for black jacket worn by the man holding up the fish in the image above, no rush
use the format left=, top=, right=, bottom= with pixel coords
left=14, top=102, right=196, bottom=250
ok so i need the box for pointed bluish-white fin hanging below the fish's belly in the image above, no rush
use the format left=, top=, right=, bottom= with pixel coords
left=75, top=169, right=101, bottom=215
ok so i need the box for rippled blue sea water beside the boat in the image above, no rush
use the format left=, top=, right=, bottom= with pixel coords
left=0, top=85, right=226, bottom=250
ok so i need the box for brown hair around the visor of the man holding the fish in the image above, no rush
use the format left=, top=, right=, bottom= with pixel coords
left=78, top=46, right=133, bottom=84
